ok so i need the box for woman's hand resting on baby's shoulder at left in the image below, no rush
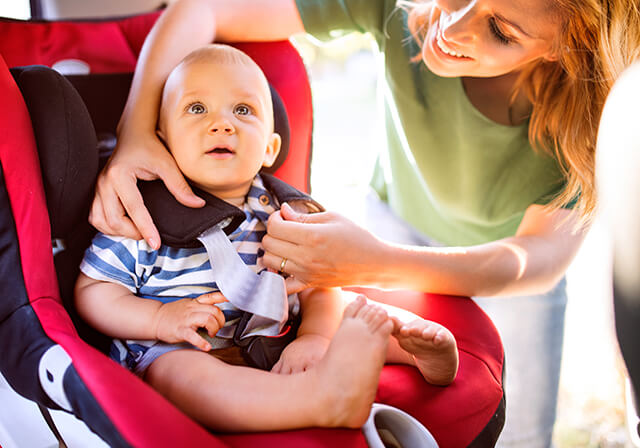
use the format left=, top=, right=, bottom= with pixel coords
left=89, top=133, right=204, bottom=249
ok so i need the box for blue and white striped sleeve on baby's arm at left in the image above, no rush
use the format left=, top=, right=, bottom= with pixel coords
left=80, top=233, right=142, bottom=293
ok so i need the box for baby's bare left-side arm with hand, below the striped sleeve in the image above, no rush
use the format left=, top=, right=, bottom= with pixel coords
left=75, top=273, right=225, bottom=350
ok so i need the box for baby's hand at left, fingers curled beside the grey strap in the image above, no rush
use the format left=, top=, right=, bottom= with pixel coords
left=154, top=292, right=227, bottom=351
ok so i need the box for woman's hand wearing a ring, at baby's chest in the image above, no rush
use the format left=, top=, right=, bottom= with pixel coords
left=262, top=204, right=382, bottom=293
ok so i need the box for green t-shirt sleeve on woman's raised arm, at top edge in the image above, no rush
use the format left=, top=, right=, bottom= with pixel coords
left=296, top=0, right=395, bottom=41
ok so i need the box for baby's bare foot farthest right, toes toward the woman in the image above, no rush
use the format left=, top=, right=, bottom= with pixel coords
left=393, top=319, right=458, bottom=386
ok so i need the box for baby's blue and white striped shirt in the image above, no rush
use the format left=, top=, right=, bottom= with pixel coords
left=80, top=175, right=297, bottom=369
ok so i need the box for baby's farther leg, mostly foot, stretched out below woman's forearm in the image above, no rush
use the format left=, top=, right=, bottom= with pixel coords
left=342, top=292, right=458, bottom=386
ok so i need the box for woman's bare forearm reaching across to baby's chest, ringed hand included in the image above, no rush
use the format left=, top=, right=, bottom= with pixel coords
left=262, top=205, right=585, bottom=296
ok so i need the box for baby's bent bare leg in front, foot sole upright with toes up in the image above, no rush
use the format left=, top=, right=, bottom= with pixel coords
left=146, top=299, right=393, bottom=431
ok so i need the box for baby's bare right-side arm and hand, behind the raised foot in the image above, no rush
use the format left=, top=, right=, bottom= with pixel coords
left=272, top=288, right=344, bottom=373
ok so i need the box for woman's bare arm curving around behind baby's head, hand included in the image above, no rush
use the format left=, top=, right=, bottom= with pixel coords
left=90, top=0, right=304, bottom=248
